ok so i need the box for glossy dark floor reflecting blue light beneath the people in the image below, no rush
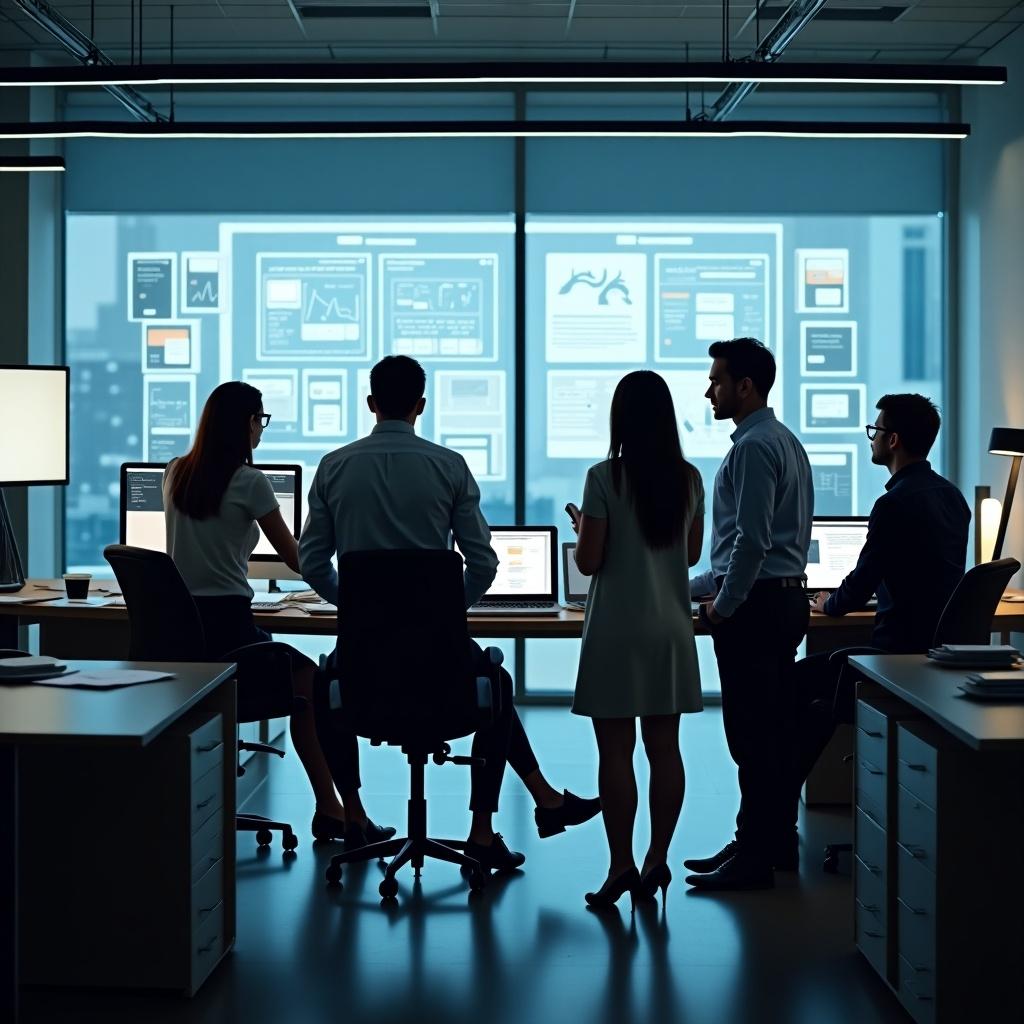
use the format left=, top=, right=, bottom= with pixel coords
left=23, top=708, right=908, bottom=1024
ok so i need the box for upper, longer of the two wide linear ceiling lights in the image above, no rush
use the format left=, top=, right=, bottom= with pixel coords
left=0, top=60, right=1007, bottom=88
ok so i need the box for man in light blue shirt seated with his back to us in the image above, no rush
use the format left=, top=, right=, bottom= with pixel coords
left=299, top=355, right=601, bottom=870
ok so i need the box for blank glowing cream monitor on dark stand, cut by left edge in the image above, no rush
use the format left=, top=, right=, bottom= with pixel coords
left=0, top=366, right=71, bottom=592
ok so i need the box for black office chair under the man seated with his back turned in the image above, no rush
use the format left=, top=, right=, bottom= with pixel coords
left=327, top=550, right=502, bottom=899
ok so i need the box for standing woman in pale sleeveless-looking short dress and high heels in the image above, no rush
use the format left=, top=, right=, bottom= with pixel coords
left=572, top=370, right=703, bottom=907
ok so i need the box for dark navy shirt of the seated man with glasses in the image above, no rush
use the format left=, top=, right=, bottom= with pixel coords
left=825, top=460, right=971, bottom=653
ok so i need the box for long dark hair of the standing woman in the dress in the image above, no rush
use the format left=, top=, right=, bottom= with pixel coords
left=608, top=370, right=696, bottom=551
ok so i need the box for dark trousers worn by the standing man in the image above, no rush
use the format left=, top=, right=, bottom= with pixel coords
left=712, top=581, right=810, bottom=863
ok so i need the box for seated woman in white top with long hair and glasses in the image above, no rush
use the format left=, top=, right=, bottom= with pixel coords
left=164, top=381, right=394, bottom=840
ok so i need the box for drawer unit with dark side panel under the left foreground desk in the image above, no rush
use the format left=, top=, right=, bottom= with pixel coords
left=22, top=706, right=234, bottom=995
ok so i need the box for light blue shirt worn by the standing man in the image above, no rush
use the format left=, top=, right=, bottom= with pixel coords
left=690, top=408, right=814, bottom=618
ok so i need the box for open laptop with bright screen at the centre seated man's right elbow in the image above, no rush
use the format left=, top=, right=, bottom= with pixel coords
left=454, top=526, right=561, bottom=615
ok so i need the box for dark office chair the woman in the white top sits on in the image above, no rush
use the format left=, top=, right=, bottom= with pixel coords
left=103, top=544, right=302, bottom=851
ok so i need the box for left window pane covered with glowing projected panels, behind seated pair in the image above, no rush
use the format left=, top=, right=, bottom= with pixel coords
left=66, top=214, right=515, bottom=566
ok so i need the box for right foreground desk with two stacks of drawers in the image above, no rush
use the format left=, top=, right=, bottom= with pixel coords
left=850, top=654, right=1024, bottom=1024
